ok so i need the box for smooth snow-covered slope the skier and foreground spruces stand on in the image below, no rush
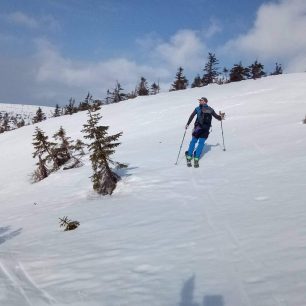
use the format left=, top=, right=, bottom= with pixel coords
left=0, top=73, right=306, bottom=306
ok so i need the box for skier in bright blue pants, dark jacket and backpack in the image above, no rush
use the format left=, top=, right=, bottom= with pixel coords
left=185, top=97, right=225, bottom=168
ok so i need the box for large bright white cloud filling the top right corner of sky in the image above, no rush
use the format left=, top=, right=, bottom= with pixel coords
left=223, top=0, right=306, bottom=72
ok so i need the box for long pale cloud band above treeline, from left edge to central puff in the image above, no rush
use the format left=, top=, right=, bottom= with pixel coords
left=0, top=30, right=207, bottom=105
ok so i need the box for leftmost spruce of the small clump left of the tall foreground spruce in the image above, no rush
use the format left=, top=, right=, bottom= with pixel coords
left=32, top=127, right=52, bottom=182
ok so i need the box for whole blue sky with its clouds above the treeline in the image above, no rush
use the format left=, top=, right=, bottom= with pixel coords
left=0, top=0, right=306, bottom=105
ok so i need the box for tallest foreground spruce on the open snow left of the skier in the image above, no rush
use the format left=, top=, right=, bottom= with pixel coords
left=82, top=109, right=126, bottom=195
